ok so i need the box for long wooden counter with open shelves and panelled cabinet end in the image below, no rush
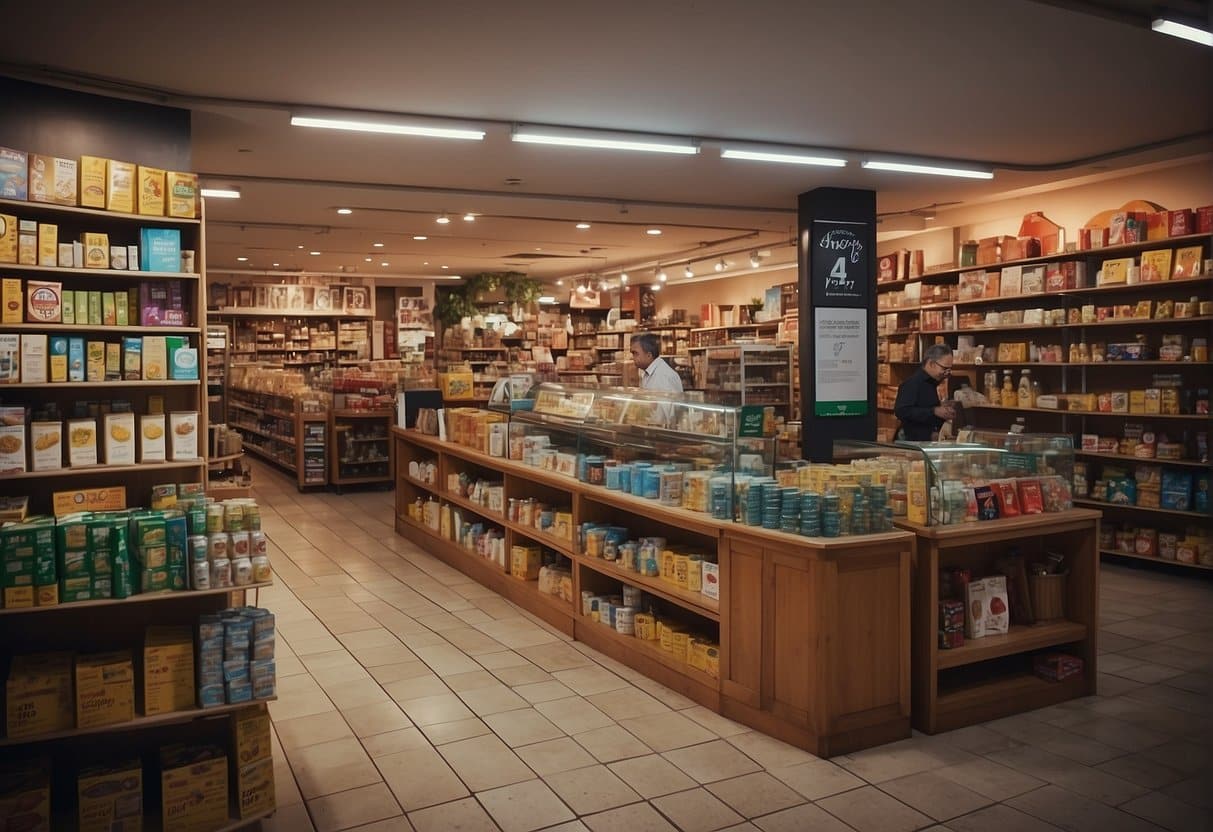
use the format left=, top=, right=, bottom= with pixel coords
left=392, top=428, right=913, bottom=757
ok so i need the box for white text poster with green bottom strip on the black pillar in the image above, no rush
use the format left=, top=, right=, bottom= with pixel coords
left=813, top=307, right=869, bottom=416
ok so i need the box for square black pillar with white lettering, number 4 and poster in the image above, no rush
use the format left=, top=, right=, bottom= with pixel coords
left=797, top=188, right=876, bottom=462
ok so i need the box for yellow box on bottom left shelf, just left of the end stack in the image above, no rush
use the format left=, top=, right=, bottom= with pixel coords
left=160, top=746, right=228, bottom=832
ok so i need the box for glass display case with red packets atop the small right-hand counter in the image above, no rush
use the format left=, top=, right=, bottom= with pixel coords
left=835, top=431, right=1074, bottom=526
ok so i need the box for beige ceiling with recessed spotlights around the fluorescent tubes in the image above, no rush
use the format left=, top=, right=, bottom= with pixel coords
left=0, top=0, right=1213, bottom=289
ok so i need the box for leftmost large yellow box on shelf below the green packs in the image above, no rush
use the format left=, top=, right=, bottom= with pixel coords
left=5, top=653, right=75, bottom=740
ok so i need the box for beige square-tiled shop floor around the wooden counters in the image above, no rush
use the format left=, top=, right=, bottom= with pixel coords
left=248, top=466, right=1213, bottom=832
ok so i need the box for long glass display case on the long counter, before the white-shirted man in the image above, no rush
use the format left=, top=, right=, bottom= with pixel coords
left=508, top=383, right=775, bottom=511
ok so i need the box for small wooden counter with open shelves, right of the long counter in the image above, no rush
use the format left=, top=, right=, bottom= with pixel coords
left=898, top=508, right=1100, bottom=734
